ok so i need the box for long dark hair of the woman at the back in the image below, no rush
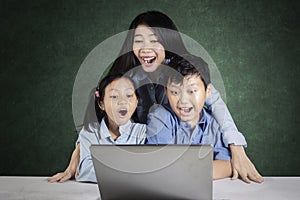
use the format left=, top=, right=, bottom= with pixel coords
left=109, top=11, right=188, bottom=74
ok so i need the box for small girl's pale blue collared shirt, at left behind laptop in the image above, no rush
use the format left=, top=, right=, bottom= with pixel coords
left=76, top=119, right=146, bottom=183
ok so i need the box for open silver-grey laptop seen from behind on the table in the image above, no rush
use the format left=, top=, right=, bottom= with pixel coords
left=90, top=145, right=213, bottom=200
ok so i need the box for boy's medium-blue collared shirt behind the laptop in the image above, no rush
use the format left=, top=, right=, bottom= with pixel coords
left=147, top=106, right=231, bottom=161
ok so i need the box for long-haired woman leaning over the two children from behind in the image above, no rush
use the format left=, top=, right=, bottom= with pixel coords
left=48, top=11, right=263, bottom=183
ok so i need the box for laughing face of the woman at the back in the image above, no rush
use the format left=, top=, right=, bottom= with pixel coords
left=132, top=25, right=166, bottom=72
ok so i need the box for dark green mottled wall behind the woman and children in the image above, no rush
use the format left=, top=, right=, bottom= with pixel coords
left=0, top=0, right=300, bottom=176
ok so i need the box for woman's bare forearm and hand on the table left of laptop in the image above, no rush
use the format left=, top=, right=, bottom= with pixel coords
left=48, top=144, right=80, bottom=183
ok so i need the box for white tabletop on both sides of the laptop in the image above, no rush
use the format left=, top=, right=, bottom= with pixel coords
left=0, top=176, right=300, bottom=200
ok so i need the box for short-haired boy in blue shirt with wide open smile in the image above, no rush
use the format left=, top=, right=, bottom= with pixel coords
left=147, top=56, right=232, bottom=179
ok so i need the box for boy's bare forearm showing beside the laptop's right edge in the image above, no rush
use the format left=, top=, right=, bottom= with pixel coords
left=213, top=160, right=232, bottom=180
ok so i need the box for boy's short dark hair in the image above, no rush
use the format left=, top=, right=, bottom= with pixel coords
left=167, top=55, right=211, bottom=90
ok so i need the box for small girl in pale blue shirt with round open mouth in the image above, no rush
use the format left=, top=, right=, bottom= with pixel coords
left=49, top=74, right=146, bottom=182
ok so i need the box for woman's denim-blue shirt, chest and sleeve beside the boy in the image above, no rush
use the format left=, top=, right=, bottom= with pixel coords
left=128, top=66, right=247, bottom=147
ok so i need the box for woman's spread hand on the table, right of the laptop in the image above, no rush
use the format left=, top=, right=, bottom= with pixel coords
left=230, top=145, right=264, bottom=183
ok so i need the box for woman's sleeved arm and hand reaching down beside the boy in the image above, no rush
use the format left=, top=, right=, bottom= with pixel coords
left=206, top=87, right=263, bottom=183
